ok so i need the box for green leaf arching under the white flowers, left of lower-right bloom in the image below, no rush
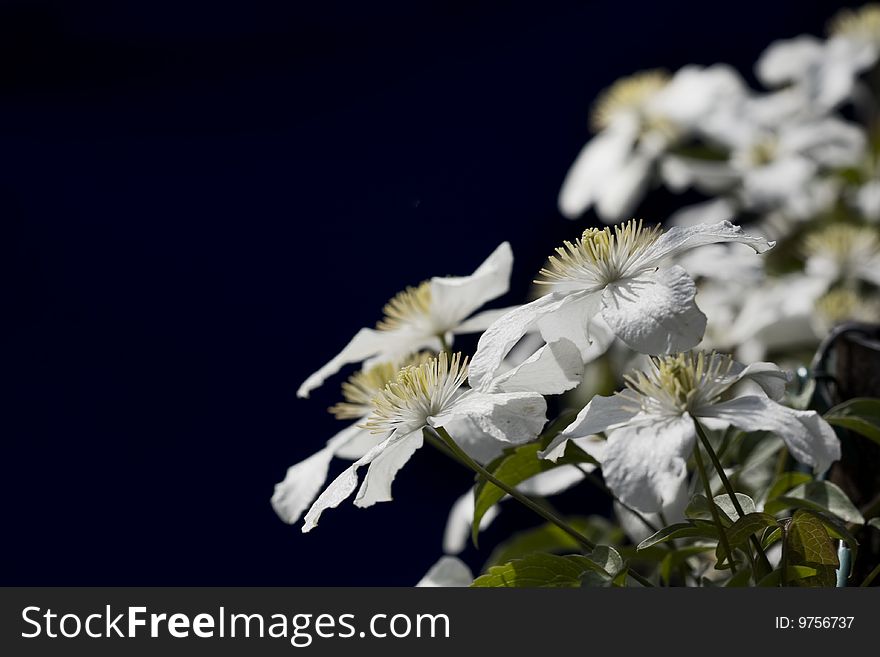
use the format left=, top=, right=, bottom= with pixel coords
left=471, top=441, right=595, bottom=545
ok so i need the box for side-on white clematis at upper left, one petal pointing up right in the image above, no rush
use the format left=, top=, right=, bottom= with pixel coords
left=296, top=242, right=513, bottom=397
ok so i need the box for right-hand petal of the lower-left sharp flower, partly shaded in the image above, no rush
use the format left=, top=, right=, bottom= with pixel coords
left=428, top=390, right=547, bottom=443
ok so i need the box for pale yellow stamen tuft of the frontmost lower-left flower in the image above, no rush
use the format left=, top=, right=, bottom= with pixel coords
left=363, top=351, right=467, bottom=434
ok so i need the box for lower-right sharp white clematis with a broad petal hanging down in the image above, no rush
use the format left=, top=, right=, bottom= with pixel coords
left=543, top=352, right=840, bottom=513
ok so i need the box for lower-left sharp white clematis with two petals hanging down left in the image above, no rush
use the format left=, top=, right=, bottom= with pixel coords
left=302, top=347, right=552, bottom=532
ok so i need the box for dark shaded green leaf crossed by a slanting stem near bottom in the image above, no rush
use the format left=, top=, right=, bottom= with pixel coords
left=486, top=516, right=623, bottom=568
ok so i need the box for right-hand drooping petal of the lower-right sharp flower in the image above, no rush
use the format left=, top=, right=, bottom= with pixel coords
left=700, top=396, right=840, bottom=473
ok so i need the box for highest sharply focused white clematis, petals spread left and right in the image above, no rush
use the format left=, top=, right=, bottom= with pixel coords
left=470, top=221, right=773, bottom=385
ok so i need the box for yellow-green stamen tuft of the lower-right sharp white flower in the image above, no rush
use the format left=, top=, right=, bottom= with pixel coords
left=624, top=351, right=733, bottom=414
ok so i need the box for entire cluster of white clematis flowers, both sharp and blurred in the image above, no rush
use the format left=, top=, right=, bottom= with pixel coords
left=272, top=6, right=880, bottom=586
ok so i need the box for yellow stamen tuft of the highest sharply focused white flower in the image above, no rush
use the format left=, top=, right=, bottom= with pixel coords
left=535, top=219, right=660, bottom=289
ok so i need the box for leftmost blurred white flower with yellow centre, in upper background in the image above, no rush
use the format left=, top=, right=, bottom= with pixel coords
left=559, top=66, right=742, bottom=223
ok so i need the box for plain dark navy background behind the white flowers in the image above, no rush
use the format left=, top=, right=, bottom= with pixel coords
left=0, top=0, right=852, bottom=585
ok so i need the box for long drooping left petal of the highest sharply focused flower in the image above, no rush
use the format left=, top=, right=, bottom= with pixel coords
left=468, top=292, right=587, bottom=389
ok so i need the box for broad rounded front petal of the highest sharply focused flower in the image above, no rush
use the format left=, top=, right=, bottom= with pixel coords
left=602, top=265, right=706, bottom=354
